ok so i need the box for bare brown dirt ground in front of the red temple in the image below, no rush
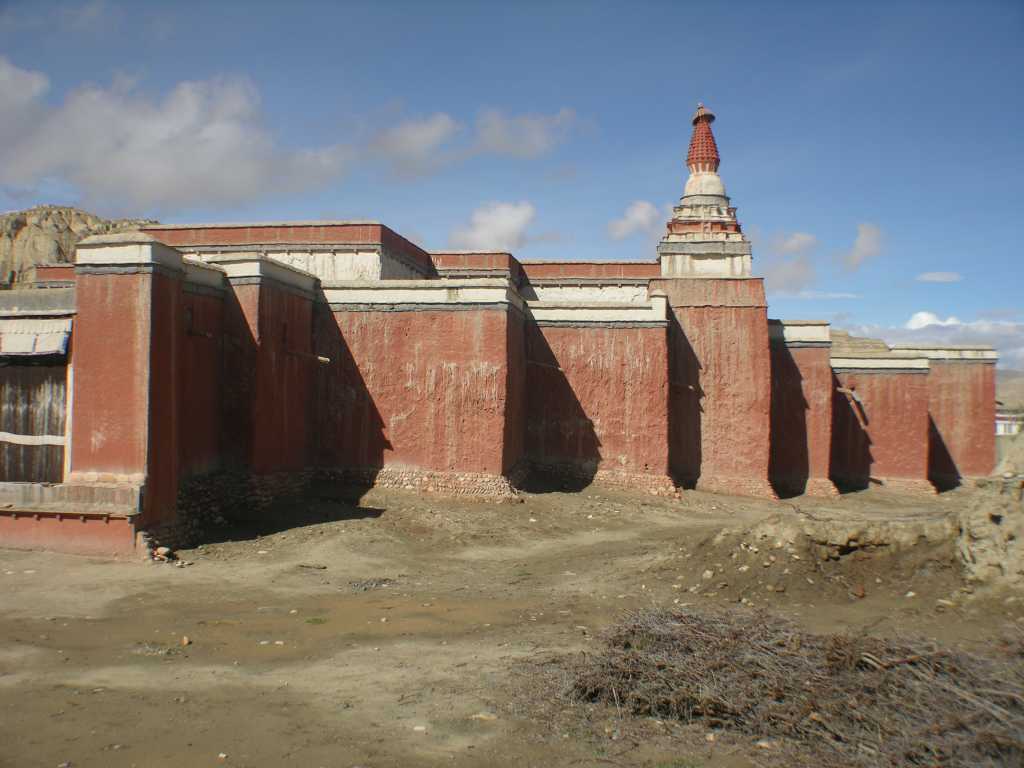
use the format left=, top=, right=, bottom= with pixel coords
left=0, top=488, right=1024, bottom=768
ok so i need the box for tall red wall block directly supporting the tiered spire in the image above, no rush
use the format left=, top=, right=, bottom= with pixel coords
left=650, top=279, right=774, bottom=498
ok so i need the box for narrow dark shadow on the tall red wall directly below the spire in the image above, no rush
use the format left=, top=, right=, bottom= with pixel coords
left=669, top=312, right=705, bottom=488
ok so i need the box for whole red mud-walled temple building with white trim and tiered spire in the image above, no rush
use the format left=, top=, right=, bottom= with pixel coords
left=0, top=105, right=995, bottom=553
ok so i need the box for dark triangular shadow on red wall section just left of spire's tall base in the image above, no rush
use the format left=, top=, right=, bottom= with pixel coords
left=522, top=323, right=601, bottom=494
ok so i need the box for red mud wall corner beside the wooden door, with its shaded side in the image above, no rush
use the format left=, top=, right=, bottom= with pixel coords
left=72, top=270, right=222, bottom=530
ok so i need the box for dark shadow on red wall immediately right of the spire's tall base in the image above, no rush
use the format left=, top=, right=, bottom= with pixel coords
left=768, top=344, right=810, bottom=499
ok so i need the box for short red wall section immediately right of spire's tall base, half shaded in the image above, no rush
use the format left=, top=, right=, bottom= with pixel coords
left=770, top=343, right=833, bottom=494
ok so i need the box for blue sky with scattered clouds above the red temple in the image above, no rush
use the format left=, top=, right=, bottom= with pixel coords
left=0, top=0, right=1024, bottom=368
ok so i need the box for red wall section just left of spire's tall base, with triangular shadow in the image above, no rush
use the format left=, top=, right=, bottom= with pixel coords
left=526, top=324, right=669, bottom=478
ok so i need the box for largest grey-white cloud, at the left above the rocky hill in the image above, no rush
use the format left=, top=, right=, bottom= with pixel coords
left=0, top=56, right=350, bottom=212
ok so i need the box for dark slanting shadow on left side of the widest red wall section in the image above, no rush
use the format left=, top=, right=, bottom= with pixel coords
left=312, top=294, right=387, bottom=498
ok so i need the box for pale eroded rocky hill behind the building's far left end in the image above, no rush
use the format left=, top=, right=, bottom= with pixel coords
left=0, top=206, right=157, bottom=284
